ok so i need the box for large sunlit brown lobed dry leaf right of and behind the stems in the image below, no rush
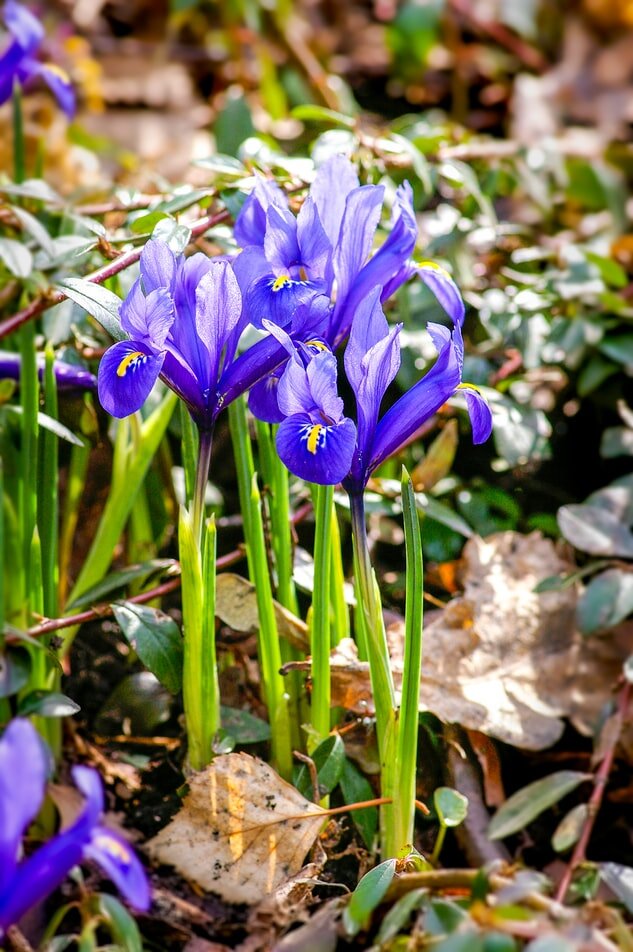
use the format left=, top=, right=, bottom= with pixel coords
left=332, top=532, right=630, bottom=750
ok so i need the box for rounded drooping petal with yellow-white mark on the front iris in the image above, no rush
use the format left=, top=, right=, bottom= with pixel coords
left=276, top=414, right=356, bottom=486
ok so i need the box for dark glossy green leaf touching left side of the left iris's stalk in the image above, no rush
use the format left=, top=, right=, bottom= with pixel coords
left=112, top=602, right=183, bottom=694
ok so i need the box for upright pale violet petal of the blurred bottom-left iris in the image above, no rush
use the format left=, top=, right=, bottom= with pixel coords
left=0, top=718, right=49, bottom=892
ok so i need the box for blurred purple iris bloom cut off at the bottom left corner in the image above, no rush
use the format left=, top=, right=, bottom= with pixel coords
left=0, top=718, right=150, bottom=938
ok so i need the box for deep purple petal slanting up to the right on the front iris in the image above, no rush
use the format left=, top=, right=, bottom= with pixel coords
left=365, top=325, right=462, bottom=479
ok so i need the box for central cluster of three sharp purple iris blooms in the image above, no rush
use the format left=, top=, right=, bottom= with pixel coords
left=99, top=156, right=491, bottom=491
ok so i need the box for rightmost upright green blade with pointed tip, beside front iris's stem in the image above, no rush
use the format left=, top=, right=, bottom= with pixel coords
left=393, top=469, right=422, bottom=850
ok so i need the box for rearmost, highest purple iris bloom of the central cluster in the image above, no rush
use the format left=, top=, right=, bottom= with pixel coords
left=235, top=155, right=464, bottom=347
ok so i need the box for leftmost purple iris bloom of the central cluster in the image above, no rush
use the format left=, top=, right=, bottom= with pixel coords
left=98, top=240, right=260, bottom=430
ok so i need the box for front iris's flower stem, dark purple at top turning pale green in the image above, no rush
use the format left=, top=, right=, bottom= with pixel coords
left=350, top=493, right=400, bottom=860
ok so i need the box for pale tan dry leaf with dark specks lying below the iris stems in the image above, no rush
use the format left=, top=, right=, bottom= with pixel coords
left=147, top=753, right=327, bottom=904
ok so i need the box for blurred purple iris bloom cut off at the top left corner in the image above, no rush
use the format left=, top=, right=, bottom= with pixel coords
left=0, top=0, right=76, bottom=118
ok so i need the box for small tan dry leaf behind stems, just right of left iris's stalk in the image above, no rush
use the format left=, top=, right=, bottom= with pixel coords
left=215, top=572, right=309, bottom=649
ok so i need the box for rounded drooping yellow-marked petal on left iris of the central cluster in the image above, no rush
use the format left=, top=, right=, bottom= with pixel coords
left=97, top=340, right=165, bottom=417
